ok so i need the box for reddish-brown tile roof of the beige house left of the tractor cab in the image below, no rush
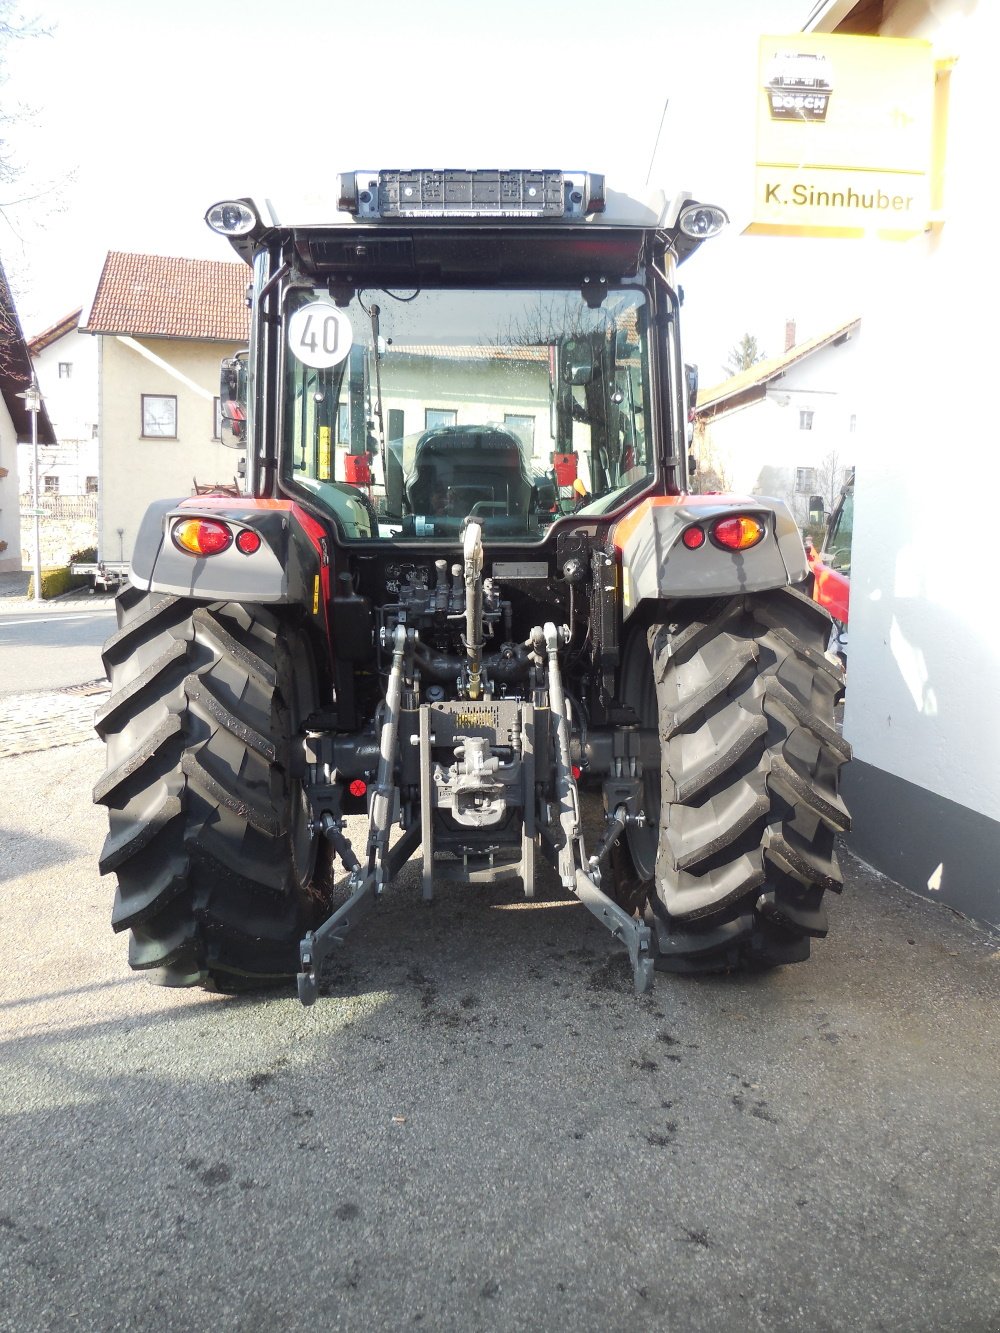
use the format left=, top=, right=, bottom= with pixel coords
left=85, top=251, right=249, bottom=343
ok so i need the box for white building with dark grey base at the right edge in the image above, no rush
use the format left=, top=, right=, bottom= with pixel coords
left=807, top=0, right=1000, bottom=922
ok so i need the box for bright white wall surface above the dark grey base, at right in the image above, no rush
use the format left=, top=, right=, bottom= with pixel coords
left=844, top=0, right=1000, bottom=820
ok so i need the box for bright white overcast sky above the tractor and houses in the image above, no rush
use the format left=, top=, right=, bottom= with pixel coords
left=0, top=0, right=861, bottom=384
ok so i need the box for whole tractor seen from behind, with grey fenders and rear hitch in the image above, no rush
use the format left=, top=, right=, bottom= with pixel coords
left=95, top=169, right=849, bottom=1004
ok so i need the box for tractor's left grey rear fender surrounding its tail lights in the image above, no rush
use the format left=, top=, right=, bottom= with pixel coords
left=129, top=496, right=329, bottom=640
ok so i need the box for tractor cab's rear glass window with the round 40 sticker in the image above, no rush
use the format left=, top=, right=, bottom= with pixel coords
left=281, top=288, right=653, bottom=541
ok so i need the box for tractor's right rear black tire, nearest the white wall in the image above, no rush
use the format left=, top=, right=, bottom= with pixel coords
left=616, top=588, right=851, bottom=972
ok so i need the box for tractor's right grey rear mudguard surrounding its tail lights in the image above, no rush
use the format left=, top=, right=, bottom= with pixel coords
left=612, top=495, right=808, bottom=619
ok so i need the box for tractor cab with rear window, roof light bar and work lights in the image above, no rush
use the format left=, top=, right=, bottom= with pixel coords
left=208, top=171, right=725, bottom=544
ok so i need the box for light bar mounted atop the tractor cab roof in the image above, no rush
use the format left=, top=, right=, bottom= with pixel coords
left=339, top=169, right=605, bottom=221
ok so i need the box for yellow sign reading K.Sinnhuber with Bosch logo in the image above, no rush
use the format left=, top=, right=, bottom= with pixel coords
left=747, top=32, right=935, bottom=237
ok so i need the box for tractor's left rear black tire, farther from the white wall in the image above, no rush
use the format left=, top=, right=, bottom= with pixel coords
left=93, top=587, right=323, bottom=990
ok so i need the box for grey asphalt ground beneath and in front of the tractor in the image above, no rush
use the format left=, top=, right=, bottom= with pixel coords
left=0, top=719, right=1000, bottom=1333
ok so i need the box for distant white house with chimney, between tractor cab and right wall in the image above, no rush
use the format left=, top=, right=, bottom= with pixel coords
left=693, top=319, right=861, bottom=527
